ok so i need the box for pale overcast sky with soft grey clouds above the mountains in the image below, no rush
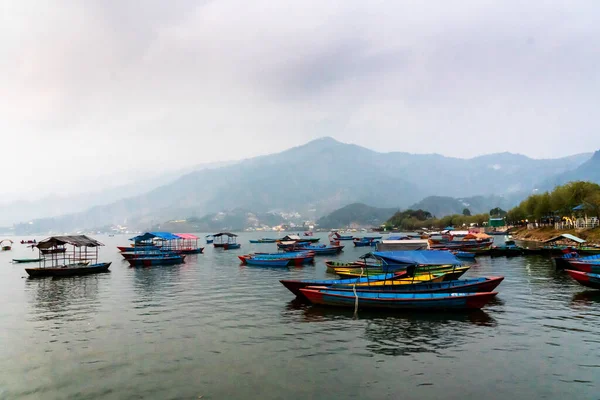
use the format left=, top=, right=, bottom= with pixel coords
left=0, top=0, right=600, bottom=197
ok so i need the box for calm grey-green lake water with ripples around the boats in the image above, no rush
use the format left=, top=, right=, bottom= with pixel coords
left=0, top=234, right=600, bottom=400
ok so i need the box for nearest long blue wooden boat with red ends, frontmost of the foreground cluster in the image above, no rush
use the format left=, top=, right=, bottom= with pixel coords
left=300, top=286, right=498, bottom=310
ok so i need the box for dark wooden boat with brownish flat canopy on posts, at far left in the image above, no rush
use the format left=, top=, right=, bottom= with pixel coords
left=25, top=235, right=111, bottom=278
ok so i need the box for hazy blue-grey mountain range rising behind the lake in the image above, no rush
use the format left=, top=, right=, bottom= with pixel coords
left=4, top=137, right=600, bottom=232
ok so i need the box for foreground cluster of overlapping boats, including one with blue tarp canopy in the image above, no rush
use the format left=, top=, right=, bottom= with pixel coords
left=280, top=250, right=504, bottom=309
